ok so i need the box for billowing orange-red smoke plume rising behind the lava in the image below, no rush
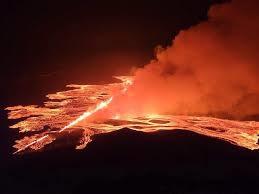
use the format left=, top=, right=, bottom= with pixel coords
left=112, top=0, right=259, bottom=118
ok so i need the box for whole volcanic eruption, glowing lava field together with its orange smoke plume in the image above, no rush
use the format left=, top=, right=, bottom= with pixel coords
left=6, top=0, right=259, bottom=153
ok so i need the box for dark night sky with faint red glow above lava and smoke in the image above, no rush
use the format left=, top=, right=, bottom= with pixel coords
left=1, top=0, right=225, bottom=104
